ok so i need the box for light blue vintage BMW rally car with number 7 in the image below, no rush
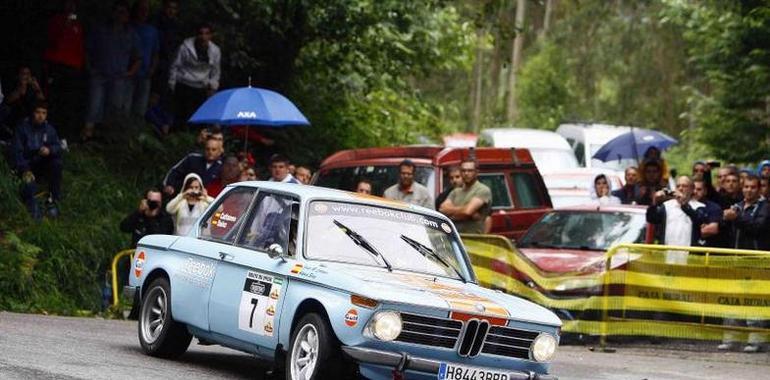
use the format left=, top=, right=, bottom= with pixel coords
left=126, top=182, right=561, bottom=380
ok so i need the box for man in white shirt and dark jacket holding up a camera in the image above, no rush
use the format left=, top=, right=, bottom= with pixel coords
left=647, top=176, right=708, bottom=264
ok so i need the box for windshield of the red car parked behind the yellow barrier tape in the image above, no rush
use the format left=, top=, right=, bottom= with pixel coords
left=518, top=211, right=647, bottom=251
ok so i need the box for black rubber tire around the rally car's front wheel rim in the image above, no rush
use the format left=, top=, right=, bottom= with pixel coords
left=284, top=312, right=342, bottom=380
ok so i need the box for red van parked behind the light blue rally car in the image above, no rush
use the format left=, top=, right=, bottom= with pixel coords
left=312, top=146, right=552, bottom=239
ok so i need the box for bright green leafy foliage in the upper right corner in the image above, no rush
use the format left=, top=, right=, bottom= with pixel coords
left=662, top=0, right=770, bottom=162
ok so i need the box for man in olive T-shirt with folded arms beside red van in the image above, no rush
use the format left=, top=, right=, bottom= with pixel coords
left=439, top=160, right=492, bottom=234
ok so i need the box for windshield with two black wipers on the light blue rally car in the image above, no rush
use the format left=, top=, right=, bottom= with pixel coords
left=305, top=201, right=465, bottom=279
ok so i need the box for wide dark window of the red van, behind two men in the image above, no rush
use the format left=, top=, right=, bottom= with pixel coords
left=314, top=164, right=435, bottom=196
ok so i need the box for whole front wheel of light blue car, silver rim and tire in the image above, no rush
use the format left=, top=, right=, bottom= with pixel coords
left=286, top=313, right=339, bottom=380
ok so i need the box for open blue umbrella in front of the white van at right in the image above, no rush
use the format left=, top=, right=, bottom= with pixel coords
left=593, top=128, right=678, bottom=162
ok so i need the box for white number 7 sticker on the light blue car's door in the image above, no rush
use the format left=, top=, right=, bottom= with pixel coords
left=238, top=271, right=283, bottom=336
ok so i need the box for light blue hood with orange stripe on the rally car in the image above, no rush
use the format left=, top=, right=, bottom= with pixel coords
left=292, top=263, right=561, bottom=326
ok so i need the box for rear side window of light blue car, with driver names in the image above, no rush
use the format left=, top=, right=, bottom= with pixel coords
left=198, top=187, right=256, bottom=243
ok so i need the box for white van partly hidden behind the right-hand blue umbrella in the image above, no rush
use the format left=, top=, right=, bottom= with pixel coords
left=556, top=123, right=632, bottom=172
